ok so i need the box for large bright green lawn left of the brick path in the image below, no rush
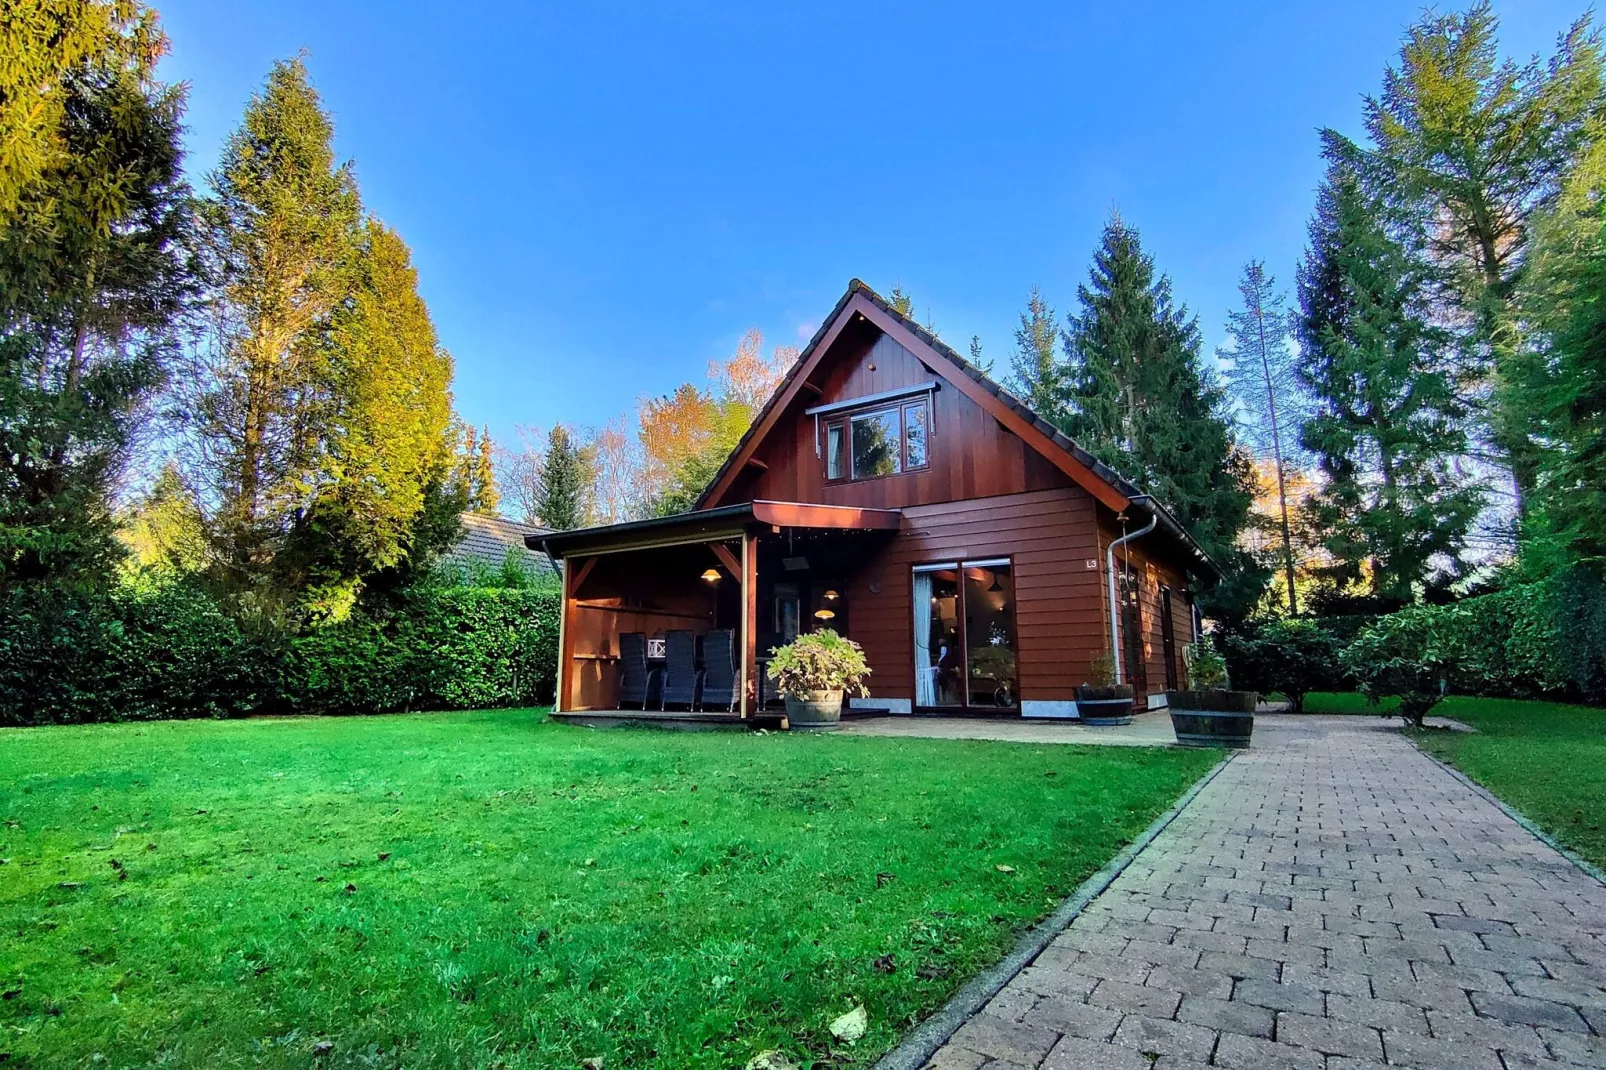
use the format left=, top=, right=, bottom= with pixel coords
left=0, top=710, right=1219, bottom=1070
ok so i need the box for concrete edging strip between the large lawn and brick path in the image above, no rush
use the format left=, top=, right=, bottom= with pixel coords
left=874, top=750, right=1238, bottom=1070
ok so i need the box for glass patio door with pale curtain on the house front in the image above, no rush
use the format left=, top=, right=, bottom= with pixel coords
left=914, top=557, right=1020, bottom=712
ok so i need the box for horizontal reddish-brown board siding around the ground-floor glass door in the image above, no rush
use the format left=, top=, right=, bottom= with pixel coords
left=848, top=487, right=1108, bottom=700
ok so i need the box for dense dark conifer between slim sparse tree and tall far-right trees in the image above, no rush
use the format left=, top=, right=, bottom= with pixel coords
left=1298, top=142, right=1481, bottom=604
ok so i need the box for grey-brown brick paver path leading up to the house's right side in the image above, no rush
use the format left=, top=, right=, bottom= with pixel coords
left=930, top=718, right=1606, bottom=1070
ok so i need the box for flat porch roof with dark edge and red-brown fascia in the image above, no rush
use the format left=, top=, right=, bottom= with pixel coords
left=524, top=501, right=903, bottom=559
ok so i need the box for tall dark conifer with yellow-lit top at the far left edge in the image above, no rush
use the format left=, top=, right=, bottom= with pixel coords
left=0, top=3, right=194, bottom=583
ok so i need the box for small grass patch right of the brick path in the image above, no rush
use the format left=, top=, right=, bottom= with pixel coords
left=1416, top=696, right=1606, bottom=868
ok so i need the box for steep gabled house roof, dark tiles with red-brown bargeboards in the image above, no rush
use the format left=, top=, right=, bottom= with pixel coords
left=694, top=280, right=1221, bottom=577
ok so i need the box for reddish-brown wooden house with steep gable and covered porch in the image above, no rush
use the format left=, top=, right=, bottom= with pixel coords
left=528, top=280, right=1216, bottom=720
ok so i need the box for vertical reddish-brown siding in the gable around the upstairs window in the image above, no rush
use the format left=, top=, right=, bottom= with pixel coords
left=708, top=325, right=1073, bottom=509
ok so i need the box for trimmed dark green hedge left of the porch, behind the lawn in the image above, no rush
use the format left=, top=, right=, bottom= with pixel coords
left=0, top=583, right=559, bottom=725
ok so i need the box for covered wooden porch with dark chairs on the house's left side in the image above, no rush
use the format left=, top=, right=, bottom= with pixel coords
left=527, top=501, right=903, bottom=728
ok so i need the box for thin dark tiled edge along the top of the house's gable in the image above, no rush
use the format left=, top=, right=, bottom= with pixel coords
left=697, top=271, right=1221, bottom=577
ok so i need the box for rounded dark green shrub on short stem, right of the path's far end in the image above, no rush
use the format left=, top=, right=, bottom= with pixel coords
left=1341, top=606, right=1455, bottom=728
